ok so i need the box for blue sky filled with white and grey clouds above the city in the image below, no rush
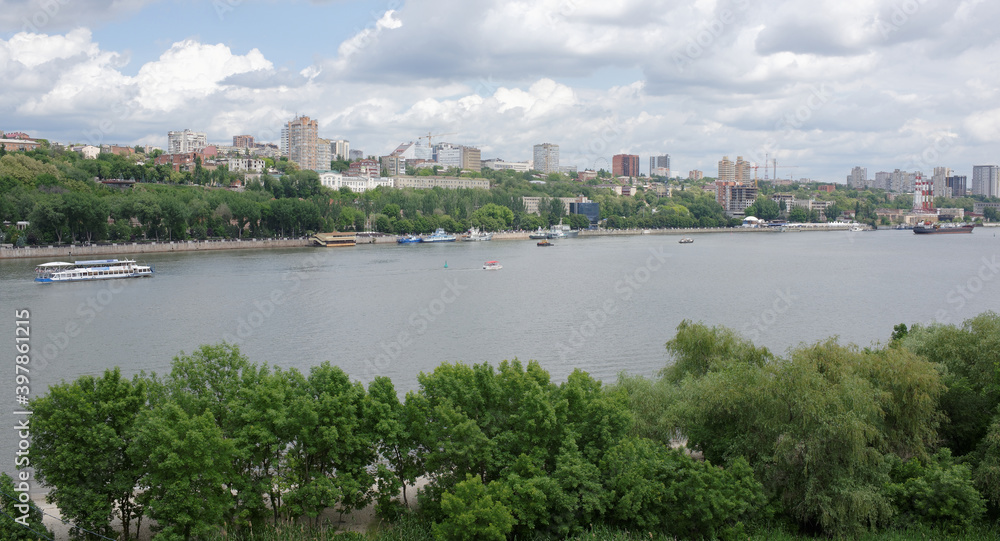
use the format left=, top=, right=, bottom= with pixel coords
left=0, top=0, right=1000, bottom=182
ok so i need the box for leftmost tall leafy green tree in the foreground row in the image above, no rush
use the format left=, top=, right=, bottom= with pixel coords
left=31, top=368, right=148, bottom=538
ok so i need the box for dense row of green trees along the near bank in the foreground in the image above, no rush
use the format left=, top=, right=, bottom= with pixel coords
left=11, top=313, right=1000, bottom=540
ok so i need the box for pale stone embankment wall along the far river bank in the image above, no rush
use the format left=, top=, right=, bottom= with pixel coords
left=0, top=224, right=850, bottom=259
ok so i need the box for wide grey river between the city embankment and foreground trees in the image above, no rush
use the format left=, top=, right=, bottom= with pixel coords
left=0, top=228, right=1000, bottom=471
